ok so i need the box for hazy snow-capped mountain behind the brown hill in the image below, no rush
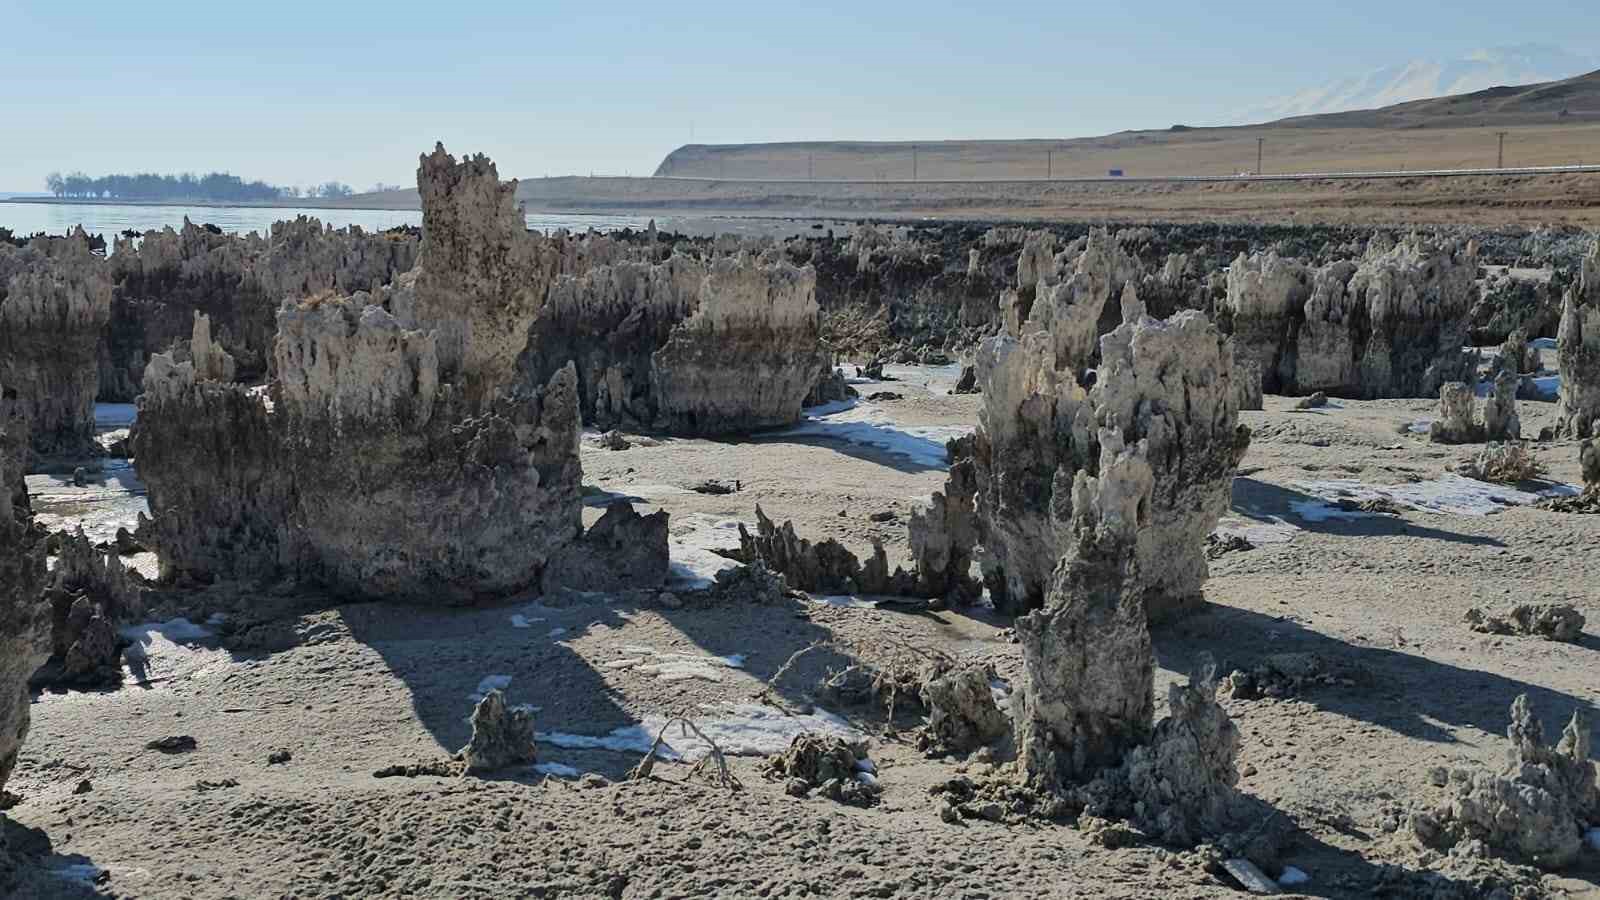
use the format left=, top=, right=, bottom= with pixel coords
left=1235, top=43, right=1600, bottom=123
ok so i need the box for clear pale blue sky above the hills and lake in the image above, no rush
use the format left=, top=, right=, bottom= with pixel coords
left=0, top=0, right=1600, bottom=191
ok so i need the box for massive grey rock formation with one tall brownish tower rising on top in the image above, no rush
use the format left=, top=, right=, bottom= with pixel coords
left=133, top=147, right=604, bottom=604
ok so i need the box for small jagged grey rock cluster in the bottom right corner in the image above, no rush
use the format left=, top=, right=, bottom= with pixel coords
left=1411, top=693, right=1600, bottom=870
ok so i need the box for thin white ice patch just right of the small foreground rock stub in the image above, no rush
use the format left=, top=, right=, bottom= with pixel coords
left=534, top=703, right=867, bottom=762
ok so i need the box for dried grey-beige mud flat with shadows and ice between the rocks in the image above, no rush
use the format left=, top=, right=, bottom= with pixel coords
left=6, top=370, right=1600, bottom=898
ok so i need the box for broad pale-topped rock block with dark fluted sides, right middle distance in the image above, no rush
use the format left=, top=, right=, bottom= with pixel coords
left=1219, top=235, right=1477, bottom=399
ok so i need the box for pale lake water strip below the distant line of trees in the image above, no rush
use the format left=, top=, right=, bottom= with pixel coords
left=0, top=202, right=650, bottom=243
